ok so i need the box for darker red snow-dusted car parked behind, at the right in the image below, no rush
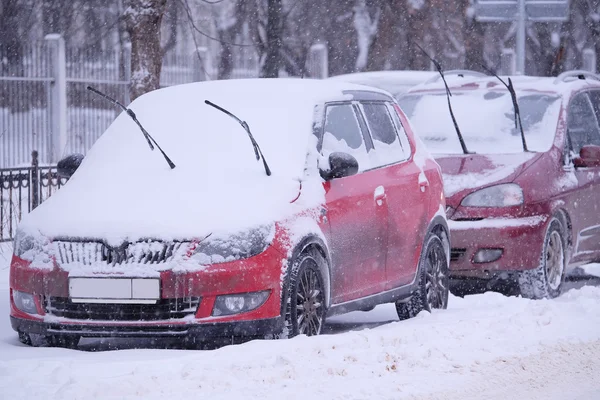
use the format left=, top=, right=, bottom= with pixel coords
left=400, top=71, right=600, bottom=299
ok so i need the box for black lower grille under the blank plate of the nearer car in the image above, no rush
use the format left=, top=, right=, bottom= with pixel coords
left=44, top=297, right=200, bottom=321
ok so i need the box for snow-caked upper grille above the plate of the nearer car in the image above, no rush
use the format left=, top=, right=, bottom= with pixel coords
left=52, top=241, right=187, bottom=265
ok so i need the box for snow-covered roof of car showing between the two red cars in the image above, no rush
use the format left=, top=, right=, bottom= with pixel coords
left=329, top=70, right=437, bottom=98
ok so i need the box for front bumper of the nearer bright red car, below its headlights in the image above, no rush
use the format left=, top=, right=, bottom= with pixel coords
left=9, top=242, right=284, bottom=339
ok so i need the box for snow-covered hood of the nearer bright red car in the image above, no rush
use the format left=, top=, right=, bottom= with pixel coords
left=20, top=174, right=314, bottom=245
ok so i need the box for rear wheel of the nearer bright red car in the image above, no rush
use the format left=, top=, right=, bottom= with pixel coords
left=396, top=233, right=449, bottom=321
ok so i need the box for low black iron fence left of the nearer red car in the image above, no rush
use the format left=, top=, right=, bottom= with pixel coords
left=0, top=151, right=67, bottom=242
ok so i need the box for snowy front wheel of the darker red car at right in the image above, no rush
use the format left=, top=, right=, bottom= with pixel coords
left=518, top=218, right=567, bottom=299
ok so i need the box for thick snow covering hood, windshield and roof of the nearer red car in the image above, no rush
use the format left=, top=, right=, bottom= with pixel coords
left=21, top=79, right=370, bottom=243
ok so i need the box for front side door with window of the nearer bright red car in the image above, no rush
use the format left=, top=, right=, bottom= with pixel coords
left=321, top=103, right=387, bottom=303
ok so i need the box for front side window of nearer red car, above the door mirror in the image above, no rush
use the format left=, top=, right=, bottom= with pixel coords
left=321, top=104, right=370, bottom=171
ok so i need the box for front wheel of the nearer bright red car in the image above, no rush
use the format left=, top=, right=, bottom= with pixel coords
left=281, top=249, right=325, bottom=337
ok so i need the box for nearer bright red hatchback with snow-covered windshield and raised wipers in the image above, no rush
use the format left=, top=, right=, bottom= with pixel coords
left=10, top=79, right=449, bottom=346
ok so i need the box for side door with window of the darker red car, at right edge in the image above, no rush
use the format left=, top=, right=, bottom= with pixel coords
left=567, top=91, right=600, bottom=262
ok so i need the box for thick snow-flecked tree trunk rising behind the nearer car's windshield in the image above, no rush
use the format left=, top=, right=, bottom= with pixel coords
left=124, top=0, right=167, bottom=101
